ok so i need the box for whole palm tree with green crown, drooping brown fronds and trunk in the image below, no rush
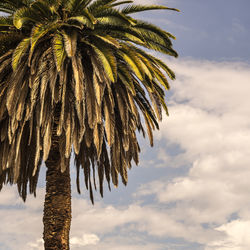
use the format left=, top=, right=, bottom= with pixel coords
left=0, top=0, right=177, bottom=249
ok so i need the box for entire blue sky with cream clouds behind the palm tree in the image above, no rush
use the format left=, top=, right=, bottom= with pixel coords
left=0, top=0, right=250, bottom=250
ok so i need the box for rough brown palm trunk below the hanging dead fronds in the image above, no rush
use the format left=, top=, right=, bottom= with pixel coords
left=43, top=106, right=71, bottom=250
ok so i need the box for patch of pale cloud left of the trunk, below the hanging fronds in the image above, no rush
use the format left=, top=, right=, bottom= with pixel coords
left=0, top=187, right=44, bottom=250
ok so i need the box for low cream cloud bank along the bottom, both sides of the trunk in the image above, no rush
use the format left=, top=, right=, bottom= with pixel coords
left=0, top=189, right=217, bottom=250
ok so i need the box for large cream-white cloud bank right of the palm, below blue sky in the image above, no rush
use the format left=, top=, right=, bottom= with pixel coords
left=137, top=60, right=250, bottom=250
